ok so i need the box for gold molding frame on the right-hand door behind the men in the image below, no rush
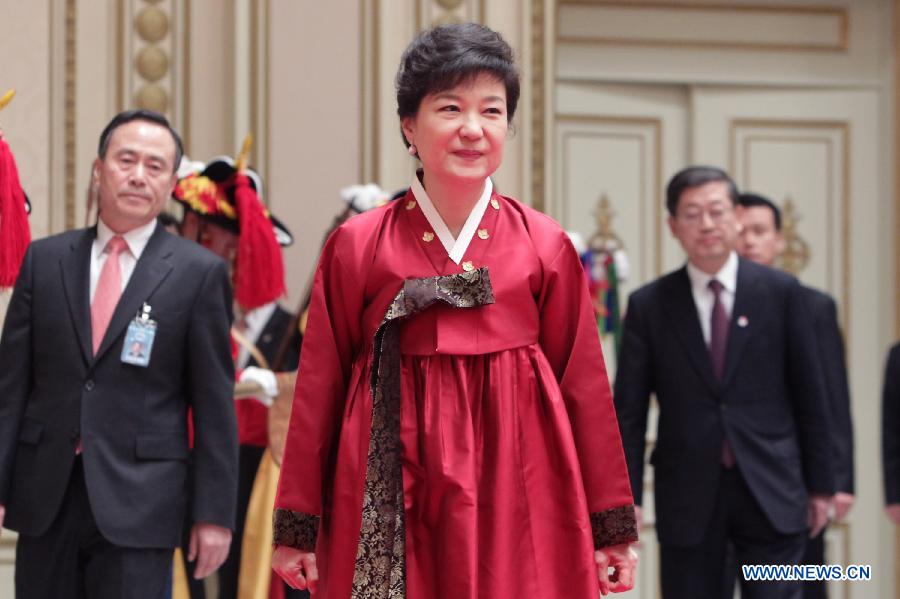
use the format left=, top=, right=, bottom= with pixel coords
left=728, top=119, right=852, bottom=354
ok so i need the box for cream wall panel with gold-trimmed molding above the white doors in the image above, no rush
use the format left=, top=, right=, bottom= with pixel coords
left=556, top=0, right=889, bottom=85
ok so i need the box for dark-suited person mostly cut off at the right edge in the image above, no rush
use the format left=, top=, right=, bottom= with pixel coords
left=881, top=343, right=900, bottom=526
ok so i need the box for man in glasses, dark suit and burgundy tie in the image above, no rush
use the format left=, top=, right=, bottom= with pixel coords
left=614, top=167, right=833, bottom=599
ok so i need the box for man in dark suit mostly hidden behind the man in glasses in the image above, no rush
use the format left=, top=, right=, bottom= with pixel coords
left=738, top=193, right=855, bottom=599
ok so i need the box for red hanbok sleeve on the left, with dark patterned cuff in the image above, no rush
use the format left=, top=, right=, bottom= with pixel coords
left=273, top=229, right=365, bottom=551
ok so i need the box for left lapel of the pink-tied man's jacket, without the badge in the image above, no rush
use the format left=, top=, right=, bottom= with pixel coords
left=59, top=227, right=97, bottom=363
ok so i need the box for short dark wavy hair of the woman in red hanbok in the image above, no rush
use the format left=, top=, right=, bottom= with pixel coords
left=396, top=23, right=519, bottom=146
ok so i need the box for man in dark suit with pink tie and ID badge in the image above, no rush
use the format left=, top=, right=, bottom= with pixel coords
left=0, top=111, right=237, bottom=599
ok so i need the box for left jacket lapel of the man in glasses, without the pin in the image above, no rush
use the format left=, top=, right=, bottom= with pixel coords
left=663, top=267, right=719, bottom=392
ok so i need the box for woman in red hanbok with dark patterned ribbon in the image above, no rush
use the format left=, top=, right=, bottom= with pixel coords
left=273, top=24, right=637, bottom=599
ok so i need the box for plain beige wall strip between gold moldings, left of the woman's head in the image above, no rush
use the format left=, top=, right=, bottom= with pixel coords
left=268, top=0, right=362, bottom=305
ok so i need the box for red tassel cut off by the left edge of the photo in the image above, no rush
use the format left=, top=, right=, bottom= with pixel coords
left=0, top=137, right=31, bottom=288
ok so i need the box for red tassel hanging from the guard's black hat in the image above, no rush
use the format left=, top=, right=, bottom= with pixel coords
left=234, top=172, right=285, bottom=310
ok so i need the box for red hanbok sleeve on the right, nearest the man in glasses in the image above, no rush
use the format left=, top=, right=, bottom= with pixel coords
left=538, top=231, right=637, bottom=547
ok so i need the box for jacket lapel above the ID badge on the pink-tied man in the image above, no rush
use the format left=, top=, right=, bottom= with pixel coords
left=95, top=225, right=172, bottom=359
